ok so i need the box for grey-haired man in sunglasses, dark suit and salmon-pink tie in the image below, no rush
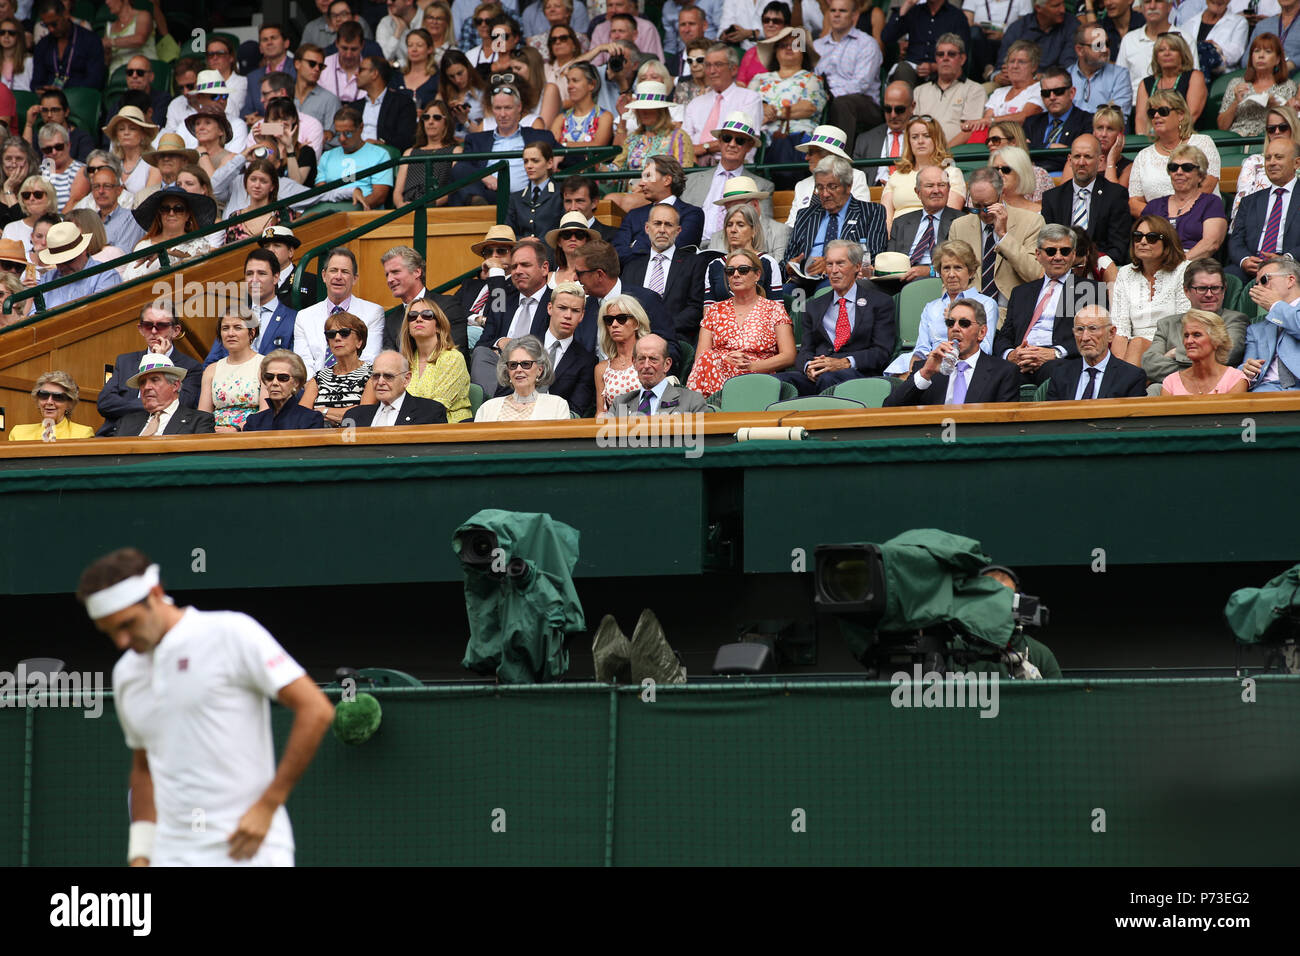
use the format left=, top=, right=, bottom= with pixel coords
left=993, top=222, right=1106, bottom=385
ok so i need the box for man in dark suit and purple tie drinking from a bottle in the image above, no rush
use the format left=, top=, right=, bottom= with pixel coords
left=884, top=299, right=1021, bottom=407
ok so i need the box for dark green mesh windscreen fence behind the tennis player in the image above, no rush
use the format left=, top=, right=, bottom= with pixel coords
left=0, top=678, right=1300, bottom=866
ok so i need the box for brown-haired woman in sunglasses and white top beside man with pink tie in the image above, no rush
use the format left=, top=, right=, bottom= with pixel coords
left=1110, top=216, right=1192, bottom=365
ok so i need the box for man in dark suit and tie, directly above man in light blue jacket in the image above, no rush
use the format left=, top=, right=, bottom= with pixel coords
left=1226, top=137, right=1300, bottom=282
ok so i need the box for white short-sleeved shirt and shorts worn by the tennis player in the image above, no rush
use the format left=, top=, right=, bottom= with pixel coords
left=113, top=607, right=304, bottom=866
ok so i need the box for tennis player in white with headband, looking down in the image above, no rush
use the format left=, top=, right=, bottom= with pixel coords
left=77, top=548, right=334, bottom=866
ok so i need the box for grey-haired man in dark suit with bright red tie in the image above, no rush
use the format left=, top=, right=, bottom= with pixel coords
left=776, top=239, right=898, bottom=395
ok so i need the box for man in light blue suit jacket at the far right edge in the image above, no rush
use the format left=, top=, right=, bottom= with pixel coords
left=1242, top=256, right=1300, bottom=392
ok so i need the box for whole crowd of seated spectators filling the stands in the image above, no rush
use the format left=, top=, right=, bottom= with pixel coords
left=0, top=0, right=1300, bottom=437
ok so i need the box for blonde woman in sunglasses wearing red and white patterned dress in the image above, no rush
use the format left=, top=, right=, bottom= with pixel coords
left=686, top=248, right=794, bottom=395
